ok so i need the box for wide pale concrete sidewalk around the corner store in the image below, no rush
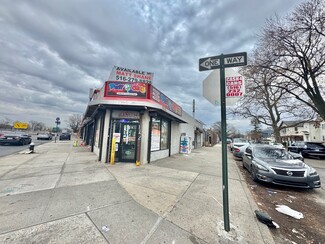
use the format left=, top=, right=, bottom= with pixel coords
left=0, top=141, right=274, bottom=244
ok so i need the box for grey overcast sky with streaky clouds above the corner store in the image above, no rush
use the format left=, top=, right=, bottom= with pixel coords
left=0, top=0, right=302, bottom=130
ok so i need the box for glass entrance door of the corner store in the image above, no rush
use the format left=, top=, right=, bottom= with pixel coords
left=119, top=123, right=139, bottom=162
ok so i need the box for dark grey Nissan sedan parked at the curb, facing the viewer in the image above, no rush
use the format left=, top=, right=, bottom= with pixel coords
left=243, top=145, right=321, bottom=188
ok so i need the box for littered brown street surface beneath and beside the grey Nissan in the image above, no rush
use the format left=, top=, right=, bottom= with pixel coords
left=236, top=154, right=325, bottom=244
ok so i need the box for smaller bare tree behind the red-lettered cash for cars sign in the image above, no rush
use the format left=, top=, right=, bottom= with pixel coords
left=228, top=58, right=314, bottom=142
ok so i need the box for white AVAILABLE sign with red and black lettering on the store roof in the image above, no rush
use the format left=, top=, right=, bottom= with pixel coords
left=108, top=66, right=153, bottom=84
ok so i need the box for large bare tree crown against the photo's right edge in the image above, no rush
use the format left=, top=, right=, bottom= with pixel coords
left=256, top=0, right=325, bottom=120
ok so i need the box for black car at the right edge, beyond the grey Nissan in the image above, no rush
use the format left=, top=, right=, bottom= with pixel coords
left=288, top=141, right=325, bottom=158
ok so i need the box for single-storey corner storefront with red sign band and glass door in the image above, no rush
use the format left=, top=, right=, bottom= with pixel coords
left=81, top=67, right=204, bottom=164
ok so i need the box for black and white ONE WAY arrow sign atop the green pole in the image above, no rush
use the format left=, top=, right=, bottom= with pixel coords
left=199, top=52, right=247, bottom=71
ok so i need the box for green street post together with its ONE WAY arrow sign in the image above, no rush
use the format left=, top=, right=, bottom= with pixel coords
left=199, top=52, right=247, bottom=231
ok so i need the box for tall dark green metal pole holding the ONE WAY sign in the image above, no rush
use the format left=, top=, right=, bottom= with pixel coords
left=220, top=54, right=230, bottom=231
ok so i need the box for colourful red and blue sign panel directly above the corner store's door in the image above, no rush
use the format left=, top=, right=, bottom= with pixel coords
left=106, top=81, right=148, bottom=98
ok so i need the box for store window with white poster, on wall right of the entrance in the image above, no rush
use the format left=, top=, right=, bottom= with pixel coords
left=151, top=118, right=169, bottom=151
